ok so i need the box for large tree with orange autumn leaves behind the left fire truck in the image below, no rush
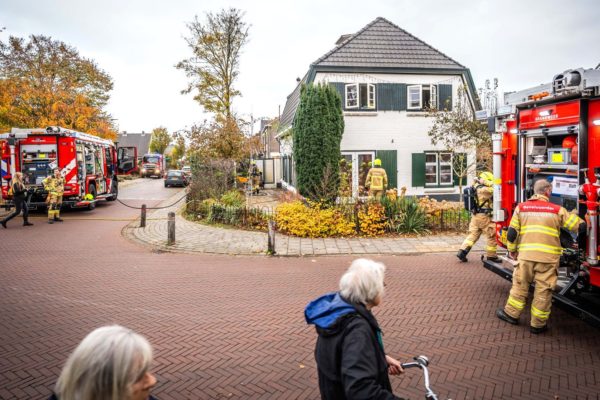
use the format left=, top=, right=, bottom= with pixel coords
left=0, top=35, right=116, bottom=139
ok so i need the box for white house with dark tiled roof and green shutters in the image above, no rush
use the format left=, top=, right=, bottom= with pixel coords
left=277, top=17, right=481, bottom=199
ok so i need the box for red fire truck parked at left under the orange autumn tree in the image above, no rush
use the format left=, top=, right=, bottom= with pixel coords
left=0, top=127, right=136, bottom=209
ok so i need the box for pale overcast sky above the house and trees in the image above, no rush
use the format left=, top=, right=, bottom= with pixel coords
left=0, top=0, right=600, bottom=132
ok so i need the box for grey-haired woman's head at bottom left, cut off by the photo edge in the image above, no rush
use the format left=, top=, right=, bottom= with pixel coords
left=49, top=325, right=156, bottom=400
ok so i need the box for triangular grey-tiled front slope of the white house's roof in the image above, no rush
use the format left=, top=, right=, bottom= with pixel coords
left=313, top=17, right=465, bottom=69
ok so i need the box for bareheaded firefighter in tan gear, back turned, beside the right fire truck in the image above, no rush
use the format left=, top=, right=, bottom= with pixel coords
left=496, top=179, right=586, bottom=334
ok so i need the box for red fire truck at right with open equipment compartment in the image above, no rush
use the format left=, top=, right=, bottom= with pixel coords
left=484, top=68, right=600, bottom=326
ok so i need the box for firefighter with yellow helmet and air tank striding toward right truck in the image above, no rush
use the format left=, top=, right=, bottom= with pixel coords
left=456, top=172, right=500, bottom=262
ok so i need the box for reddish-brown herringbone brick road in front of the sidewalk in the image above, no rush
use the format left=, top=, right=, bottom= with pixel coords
left=0, top=182, right=600, bottom=400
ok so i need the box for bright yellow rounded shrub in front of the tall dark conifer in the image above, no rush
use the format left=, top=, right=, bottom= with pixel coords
left=275, top=201, right=355, bottom=237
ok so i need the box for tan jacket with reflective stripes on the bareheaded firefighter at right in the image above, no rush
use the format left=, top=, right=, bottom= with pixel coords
left=507, top=195, right=583, bottom=263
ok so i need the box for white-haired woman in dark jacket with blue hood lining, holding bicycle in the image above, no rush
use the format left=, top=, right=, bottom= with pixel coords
left=304, top=258, right=403, bottom=400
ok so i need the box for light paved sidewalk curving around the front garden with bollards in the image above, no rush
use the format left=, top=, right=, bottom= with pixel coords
left=123, top=194, right=484, bottom=258
